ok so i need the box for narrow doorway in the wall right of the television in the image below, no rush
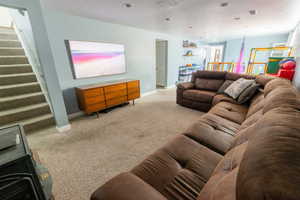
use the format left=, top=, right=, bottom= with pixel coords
left=156, top=40, right=168, bottom=88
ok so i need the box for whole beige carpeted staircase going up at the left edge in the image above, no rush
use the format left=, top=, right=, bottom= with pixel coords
left=0, top=27, right=54, bottom=133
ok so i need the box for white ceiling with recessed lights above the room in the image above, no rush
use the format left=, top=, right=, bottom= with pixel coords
left=42, top=0, right=300, bottom=42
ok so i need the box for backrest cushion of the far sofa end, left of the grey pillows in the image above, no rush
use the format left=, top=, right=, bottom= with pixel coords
left=195, top=78, right=224, bottom=91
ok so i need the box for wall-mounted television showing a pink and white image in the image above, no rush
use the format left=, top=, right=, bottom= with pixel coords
left=66, top=40, right=126, bottom=79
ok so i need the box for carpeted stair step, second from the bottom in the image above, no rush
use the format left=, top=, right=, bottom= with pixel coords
left=0, top=103, right=51, bottom=126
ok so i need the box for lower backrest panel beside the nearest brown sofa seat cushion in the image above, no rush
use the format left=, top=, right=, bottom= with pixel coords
left=197, top=143, right=248, bottom=200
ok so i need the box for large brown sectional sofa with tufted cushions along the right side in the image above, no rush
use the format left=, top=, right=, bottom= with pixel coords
left=91, top=72, right=300, bottom=200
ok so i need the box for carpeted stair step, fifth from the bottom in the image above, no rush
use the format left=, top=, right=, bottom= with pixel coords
left=0, top=73, right=37, bottom=85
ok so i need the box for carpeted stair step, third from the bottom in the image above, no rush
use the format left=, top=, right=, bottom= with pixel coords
left=0, top=92, right=46, bottom=112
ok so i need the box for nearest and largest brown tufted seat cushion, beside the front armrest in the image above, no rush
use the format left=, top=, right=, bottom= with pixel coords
left=132, top=135, right=222, bottom=200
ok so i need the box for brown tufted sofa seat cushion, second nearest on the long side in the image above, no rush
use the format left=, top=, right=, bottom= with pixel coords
left=184, top=113, right=240, bottom=155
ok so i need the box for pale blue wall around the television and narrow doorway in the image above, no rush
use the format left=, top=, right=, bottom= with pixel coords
left=44, top=8, right=189, bottom=113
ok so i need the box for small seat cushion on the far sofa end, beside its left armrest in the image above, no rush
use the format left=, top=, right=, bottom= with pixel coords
left=183, top=90, right=216, bottom=103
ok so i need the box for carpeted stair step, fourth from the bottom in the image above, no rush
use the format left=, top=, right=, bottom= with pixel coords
left=0, top=82, right=41, bottom=97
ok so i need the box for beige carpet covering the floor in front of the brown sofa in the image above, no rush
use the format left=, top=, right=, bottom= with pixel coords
left=28, top=89, right=203, bottom=200
